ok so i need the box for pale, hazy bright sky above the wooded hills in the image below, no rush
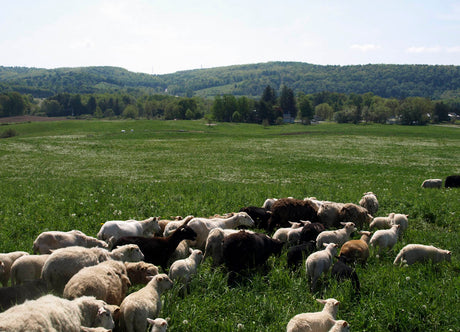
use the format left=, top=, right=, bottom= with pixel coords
left=0, top=0, right=460, bottom=74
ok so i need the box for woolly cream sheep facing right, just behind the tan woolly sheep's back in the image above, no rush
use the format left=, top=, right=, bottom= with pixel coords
left=42, top=244, right=144, bottom=294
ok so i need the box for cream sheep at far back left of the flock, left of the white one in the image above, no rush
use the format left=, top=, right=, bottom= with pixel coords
left=33, top=230, right=108, bottom=254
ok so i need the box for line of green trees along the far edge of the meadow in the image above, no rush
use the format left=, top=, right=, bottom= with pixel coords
left=0, top=85, right=460, bottom=125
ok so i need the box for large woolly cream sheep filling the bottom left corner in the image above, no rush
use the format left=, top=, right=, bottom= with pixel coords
left=0, top=295, right=115, bottom=332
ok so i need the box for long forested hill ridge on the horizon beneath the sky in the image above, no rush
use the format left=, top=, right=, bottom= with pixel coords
left=0, top=62, right=460, bottom=99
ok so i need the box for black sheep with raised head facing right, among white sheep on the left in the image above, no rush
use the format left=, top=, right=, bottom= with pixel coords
left=114, top=219, right=196, bottom=271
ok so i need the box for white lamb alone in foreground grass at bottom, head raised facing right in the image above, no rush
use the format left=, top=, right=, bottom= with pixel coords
left=286, top=299, right=340, bottom=332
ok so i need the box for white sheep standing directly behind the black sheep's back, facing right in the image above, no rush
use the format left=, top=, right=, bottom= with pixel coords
left=97, top=217, right=160, bottom=242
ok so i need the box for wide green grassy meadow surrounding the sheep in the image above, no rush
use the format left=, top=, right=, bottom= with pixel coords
left=0, top=120, right=460, bottom=331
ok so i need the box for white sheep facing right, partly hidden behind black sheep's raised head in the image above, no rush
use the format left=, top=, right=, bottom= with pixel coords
left=164, top=212, right=254, bottom=251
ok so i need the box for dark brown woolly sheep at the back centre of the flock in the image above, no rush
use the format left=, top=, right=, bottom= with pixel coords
left=267, top=198, right=318, bottom=231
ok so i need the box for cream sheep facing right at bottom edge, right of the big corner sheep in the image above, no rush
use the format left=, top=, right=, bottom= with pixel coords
left=120, top=274, right=173, bottom=332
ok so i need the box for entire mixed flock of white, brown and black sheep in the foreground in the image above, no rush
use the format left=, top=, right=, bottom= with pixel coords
left=0, top=183, right=451, bottom=332
